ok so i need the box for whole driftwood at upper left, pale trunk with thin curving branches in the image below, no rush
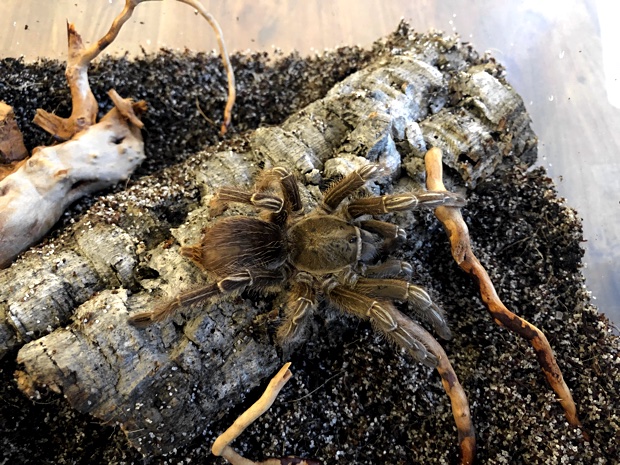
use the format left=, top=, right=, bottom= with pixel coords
left=0, top=0, right=235, bottom=268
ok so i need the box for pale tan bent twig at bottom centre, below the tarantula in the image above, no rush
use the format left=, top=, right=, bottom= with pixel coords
left=211, top=362, right=320, bottom=465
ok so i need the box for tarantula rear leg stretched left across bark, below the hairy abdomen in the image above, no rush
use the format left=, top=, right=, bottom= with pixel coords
left=129, top=270, right=283, bottom=327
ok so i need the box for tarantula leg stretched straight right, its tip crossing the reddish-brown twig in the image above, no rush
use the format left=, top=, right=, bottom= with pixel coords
left=347, top=191, right=466, bottom=218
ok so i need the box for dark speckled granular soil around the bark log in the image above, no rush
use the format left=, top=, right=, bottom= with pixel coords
left=0, top=26, right=620, bottom=465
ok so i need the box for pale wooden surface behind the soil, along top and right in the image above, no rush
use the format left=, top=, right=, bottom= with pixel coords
left=0, top=0, right=620, bottom=323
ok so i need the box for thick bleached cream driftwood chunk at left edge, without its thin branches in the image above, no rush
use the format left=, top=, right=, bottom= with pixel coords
left=0, top=95, right=145, bottom=268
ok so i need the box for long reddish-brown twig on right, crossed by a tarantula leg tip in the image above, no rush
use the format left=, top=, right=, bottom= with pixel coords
left=425, top=148, right=581, bottom=426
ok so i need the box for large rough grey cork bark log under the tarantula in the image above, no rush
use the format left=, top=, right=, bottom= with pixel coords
left=0, top=32, right=548, bottom=454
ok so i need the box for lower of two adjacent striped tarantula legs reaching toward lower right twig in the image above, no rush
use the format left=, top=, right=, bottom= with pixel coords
left=327, top=285, right=438, bottom=368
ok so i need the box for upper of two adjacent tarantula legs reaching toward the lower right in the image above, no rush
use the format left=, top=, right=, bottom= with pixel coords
left=355, top=278, right=452, bottom=340
